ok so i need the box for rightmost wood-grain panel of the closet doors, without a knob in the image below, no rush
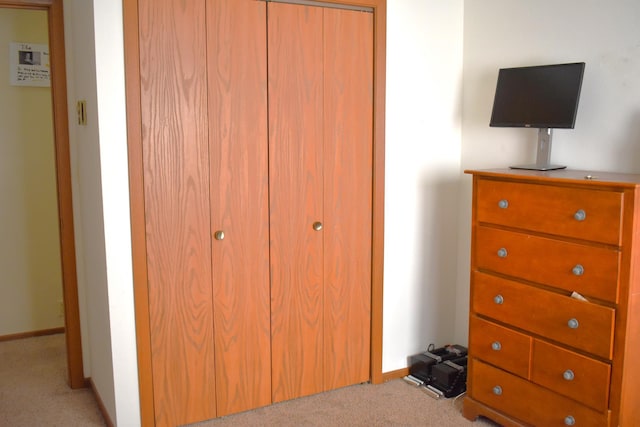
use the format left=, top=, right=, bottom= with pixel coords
left=323, top=9, right=373, bottom=390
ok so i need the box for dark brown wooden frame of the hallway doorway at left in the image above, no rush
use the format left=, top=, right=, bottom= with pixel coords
left=0, top=0, right=87, bottom=389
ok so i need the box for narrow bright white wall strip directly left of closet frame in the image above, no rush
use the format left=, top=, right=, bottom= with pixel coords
left=93, top=0, right=140, bottom=426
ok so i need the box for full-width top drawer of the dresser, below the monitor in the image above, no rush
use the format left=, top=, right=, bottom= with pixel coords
left=476, top=178, right=622, bottom=245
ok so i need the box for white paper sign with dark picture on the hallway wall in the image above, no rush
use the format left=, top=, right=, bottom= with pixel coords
left=9, top=43, right=51, bottom=87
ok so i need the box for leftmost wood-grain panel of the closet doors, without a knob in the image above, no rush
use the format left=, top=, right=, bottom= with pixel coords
left=138, top=0, right=216, bottom=426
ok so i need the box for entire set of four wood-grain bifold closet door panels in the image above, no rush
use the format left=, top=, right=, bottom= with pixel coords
left=138, top=0, right=373, bottom=426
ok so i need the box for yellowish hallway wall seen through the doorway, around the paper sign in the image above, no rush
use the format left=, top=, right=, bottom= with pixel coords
left=0, top=8, right=64, bottom=336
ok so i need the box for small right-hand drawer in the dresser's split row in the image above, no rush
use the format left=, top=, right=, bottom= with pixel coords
left=531, top=340, right=611, bottom=411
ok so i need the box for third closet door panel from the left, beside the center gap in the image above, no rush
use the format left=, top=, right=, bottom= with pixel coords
left=268, top=3, right=324, bottom=402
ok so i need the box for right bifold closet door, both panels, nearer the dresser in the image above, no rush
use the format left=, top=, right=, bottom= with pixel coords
left=268, top=3, right=373, bottom=401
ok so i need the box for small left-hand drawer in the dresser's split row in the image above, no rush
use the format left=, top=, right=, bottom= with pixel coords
left=469, top=316, right=532, bottom=378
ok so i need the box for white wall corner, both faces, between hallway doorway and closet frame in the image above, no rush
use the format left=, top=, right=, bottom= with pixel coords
left=64, top=0, right=140, bottom=426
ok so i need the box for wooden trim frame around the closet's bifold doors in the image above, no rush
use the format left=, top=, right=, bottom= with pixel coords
left=123, top=0, right=387, bottom=425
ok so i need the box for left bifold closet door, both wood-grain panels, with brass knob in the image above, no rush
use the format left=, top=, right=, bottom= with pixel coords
left=139, top=0, right=271, bottom=425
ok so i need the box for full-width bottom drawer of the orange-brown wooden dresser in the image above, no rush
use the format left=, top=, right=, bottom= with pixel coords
left=469, top=359, right=609, bottom=427
